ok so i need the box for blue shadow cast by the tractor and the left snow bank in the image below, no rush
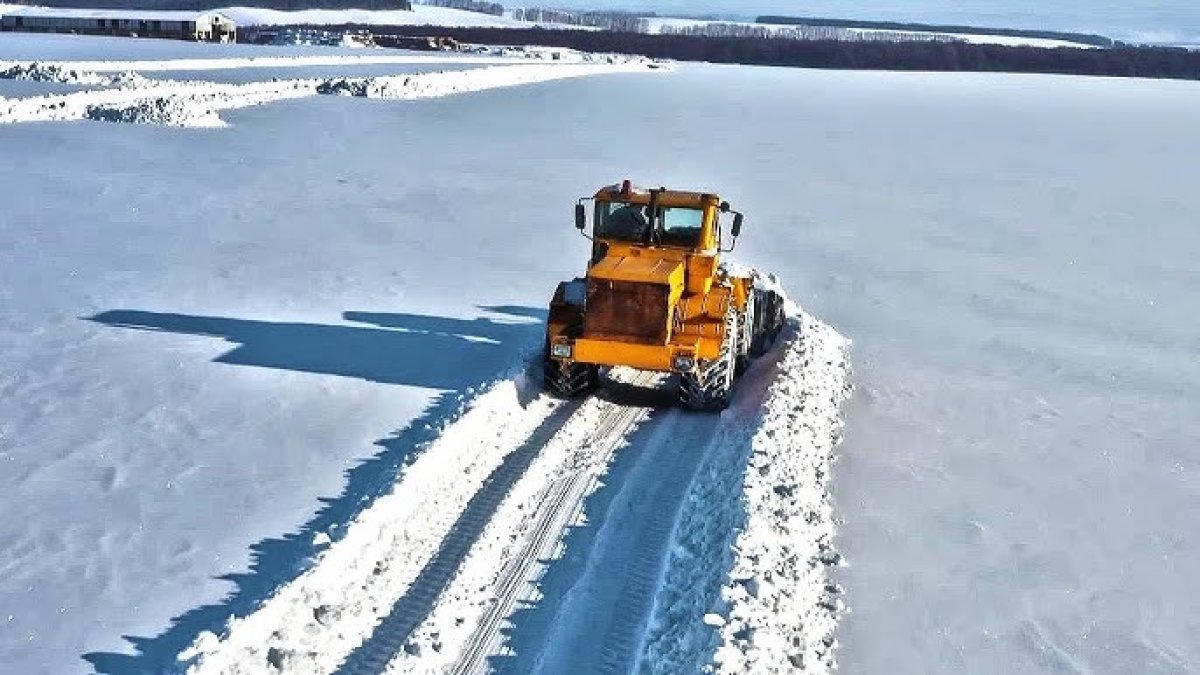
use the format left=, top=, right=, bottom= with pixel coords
left=83, top=306, right=546, bottom=675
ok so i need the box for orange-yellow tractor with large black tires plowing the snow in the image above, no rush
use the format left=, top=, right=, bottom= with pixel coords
left=544, top=180, right=784, bottom=411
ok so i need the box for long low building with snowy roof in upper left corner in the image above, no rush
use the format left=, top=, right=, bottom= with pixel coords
left=0, top=7, right=238, bottom=42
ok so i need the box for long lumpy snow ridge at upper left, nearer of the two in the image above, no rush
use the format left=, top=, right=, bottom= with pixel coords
left=0, top=61, right=667, bottom=127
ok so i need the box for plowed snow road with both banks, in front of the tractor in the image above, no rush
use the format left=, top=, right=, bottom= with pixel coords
left=180, top=315, right=846, bottom=675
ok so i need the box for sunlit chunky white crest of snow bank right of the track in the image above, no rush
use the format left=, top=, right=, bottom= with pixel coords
left=713, top=306, right=850, bottom=673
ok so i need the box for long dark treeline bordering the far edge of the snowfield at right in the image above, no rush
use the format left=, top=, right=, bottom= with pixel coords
left=336, top=25, right=1200, bottom=79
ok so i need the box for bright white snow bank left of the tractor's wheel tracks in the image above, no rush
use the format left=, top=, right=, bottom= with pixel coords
left=179, top=381, right=560, bottom=675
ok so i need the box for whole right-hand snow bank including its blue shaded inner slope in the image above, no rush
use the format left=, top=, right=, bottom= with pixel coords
left=638, top=306, right=850, bottom=673
